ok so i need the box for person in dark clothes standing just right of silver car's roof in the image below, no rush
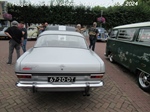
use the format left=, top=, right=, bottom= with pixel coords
left=88, top=22, right=98, bottom=51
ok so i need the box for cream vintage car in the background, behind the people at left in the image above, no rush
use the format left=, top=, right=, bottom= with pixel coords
left=27, top=26, right=39, bottom=39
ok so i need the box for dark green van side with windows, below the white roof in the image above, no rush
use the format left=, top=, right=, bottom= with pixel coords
left=106, top=27, right=150, bottom=73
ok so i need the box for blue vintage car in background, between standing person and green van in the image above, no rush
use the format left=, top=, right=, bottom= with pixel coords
left=97, top=27, right=108, bottom=41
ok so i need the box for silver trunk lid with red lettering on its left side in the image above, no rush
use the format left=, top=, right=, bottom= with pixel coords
left=21, top=48, right=101, bottom=73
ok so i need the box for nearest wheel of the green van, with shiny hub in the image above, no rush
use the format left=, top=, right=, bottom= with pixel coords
left=138, top=71, right=150, bottom=92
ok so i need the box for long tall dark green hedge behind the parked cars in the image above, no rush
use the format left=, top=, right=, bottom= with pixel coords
left=7, top=0, right=150, bottom=29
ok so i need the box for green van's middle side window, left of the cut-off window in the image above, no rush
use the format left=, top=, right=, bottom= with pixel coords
left=118, top=29, right=136, bottom=41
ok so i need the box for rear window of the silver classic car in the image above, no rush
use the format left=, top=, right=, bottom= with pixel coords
left=34, top=35, right=88, bottom=49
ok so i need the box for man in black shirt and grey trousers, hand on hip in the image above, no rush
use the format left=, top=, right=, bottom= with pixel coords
left=5, top=21, right=23, bottom=65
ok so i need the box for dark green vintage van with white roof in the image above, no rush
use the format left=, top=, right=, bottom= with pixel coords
left=105, top=22, right=150, bottom=91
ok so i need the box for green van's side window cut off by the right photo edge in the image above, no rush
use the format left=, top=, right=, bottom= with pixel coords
left=138, top=28, right=150, bottom=42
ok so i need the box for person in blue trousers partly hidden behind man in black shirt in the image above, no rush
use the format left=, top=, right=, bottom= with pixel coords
left=20, top=21, right=27, bottom=52
